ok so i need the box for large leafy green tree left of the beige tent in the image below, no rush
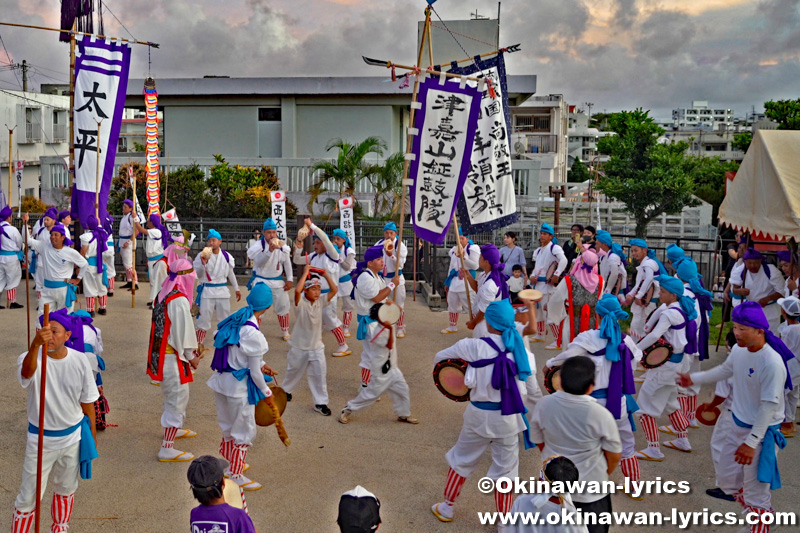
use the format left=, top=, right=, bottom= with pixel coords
left=597, top=109, right=697, bottom=237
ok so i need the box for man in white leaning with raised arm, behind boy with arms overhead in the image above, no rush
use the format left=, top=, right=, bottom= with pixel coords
left=294, top=218, right=353, bottom=357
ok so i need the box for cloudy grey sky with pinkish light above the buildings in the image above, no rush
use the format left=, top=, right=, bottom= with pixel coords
left=0, top=0, right=800, bottom=117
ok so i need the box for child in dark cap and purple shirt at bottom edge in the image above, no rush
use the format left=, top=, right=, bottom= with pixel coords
left=186, top=455, right=256, bottom=533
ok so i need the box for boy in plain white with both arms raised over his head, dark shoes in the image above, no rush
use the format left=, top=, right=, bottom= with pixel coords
left=283, top=265, right=338, bottom=416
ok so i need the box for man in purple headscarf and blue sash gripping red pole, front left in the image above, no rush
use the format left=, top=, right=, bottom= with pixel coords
left=11, top=308, right=100, bottom=533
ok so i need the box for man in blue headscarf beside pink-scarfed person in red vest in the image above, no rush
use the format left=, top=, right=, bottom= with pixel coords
left=194, top=228, right=242, bottom=347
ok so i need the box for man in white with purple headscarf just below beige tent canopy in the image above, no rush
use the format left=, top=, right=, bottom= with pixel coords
left=730, top=248, right=786, bottom=335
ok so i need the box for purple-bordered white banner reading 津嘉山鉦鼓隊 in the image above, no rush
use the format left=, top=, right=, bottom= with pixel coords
left=409, top=77, right=481, bottom=244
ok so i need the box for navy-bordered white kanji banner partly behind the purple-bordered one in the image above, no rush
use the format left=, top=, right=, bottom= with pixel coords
left=450, top=53, right=519, bottom=234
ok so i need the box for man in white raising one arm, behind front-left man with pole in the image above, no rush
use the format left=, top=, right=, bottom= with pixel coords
left=22, top=213, right=89, bottom=316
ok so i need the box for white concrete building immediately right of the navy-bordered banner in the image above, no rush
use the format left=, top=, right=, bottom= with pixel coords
left=511, top=94, right=569, bottom=183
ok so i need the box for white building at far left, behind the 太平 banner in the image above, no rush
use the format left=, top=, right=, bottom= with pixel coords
left=0, top=89, right=69, bottom=206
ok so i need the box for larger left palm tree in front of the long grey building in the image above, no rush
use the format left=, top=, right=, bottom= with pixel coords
left=308, top=137, right=386, bottom=213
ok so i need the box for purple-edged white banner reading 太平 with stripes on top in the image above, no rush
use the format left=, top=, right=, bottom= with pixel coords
left=72, top=36, right=131, bottom=226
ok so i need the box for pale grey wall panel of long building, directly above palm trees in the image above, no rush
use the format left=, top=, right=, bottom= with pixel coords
left=296, top=103, right=401, bottom=158
